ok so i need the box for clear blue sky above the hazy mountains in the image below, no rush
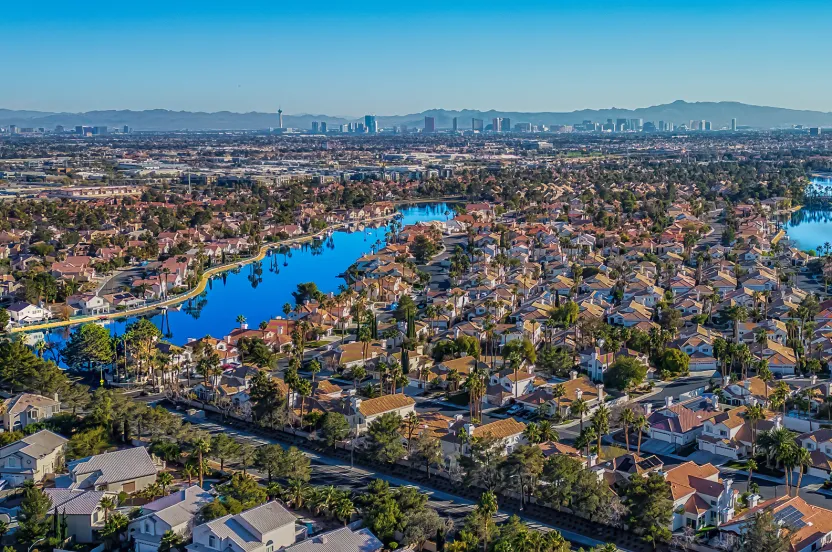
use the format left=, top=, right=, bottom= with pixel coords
left=0, top=0, right=832, bottom=115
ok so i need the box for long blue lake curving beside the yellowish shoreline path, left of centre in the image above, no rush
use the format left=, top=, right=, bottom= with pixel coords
left=37, top=203, right=452, bottom=345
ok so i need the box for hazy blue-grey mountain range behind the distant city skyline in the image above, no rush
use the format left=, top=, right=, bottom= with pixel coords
left=0, top=100, right=832, bottom=131
